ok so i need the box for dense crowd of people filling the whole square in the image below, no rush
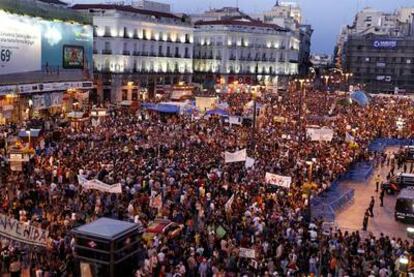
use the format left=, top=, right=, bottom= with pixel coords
left=0, top=91, right=414, bottom=277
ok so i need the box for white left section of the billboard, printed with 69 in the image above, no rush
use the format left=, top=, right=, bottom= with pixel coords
left=0, top=11, right=42, bottom=75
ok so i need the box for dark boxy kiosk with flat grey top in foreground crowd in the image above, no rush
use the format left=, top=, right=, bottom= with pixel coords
left=72, top=217, right=141, bottom=277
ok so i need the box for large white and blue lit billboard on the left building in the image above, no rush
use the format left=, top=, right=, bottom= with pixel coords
left=0, top=11, right=93, bottom=75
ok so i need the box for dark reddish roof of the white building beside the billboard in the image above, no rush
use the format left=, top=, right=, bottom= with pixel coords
left=72, top=4, right=181, bottom=20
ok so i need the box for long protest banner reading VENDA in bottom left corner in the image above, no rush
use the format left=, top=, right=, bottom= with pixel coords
left=0, top=214, right=49, bottom=246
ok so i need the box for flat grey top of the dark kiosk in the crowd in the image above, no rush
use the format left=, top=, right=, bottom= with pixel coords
left=73, top=217, right=138, bottom=240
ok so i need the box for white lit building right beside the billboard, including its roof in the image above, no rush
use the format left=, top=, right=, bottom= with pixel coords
left=73, top=4, right=194, bottom=102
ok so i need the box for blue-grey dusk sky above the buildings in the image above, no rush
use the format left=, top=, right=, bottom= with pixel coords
left=73, top=0, right=414, bottom=54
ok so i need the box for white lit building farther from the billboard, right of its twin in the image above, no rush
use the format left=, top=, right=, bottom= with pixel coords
left=194, top=18, right=300, bottom=85
